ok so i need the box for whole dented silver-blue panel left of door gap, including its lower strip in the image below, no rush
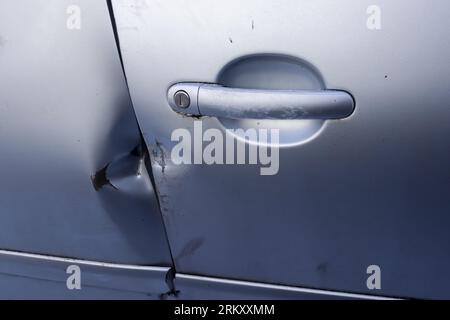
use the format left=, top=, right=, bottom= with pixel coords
left=0, top=0, right=172, bottom=299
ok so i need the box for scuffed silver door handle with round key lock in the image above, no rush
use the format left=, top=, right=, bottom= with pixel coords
left=168, top=82, right=355, bottom=120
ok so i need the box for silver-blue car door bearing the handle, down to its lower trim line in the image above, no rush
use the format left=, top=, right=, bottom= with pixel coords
left=113, top=0, right=450, bottom=298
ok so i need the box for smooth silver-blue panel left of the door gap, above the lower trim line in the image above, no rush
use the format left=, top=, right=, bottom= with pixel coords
left=0, top=0, right=171, bottom=266
